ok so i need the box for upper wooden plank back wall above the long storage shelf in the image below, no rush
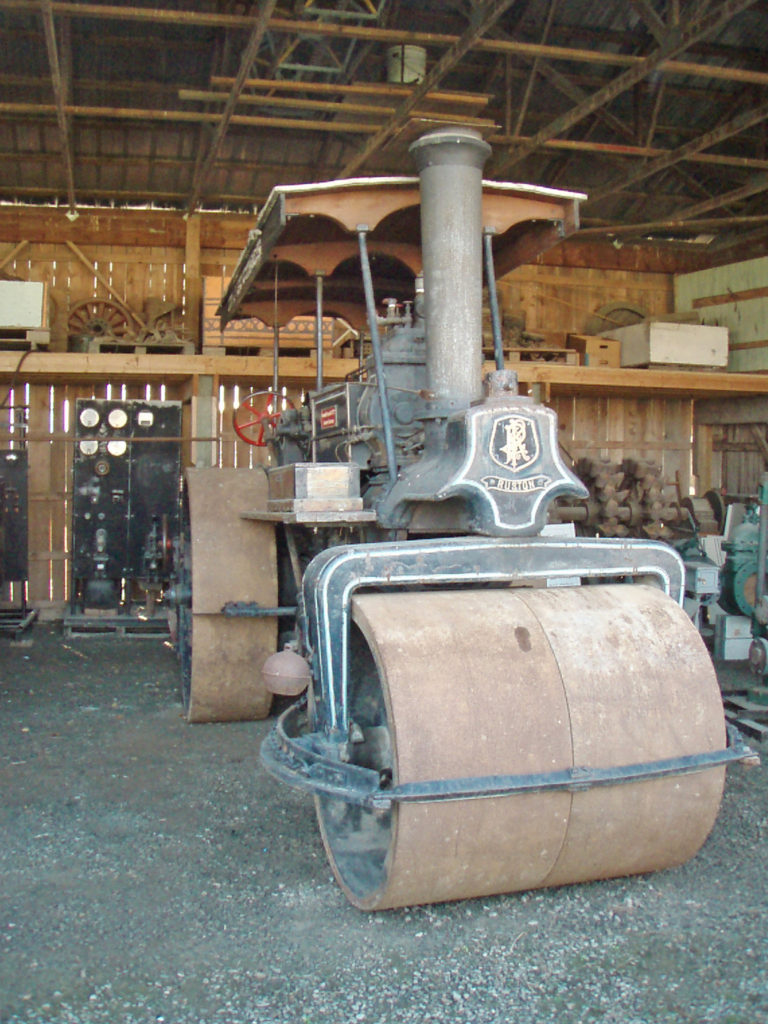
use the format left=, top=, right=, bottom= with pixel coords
left=0, top=207, right=674, bottom=351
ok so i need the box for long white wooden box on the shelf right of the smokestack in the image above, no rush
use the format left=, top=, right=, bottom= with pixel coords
left=602, top=321, right=728, bottom=368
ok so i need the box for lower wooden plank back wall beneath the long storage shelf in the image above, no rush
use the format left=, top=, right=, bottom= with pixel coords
left=0, top=381, right=692, bottom=616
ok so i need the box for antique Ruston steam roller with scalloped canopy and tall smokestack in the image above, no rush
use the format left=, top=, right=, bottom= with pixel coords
left=178, top=126, right=755, bottom=910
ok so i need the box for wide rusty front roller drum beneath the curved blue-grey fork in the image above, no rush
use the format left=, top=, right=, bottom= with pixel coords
left=316, top=585, right=725, bottom=909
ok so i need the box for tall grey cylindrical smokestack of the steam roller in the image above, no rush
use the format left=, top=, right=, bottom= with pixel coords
left=410, top=128, right=490, bottom=412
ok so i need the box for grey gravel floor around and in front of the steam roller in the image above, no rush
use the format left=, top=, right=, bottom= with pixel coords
left=0, top=626, right=768, bottom=1024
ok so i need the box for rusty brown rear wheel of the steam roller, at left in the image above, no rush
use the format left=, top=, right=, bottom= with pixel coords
left=186, top=469, right=278, bottom=722
